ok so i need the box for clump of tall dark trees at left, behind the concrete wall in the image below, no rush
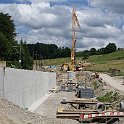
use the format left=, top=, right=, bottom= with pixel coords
left=0, top=13, right=33, bottom=69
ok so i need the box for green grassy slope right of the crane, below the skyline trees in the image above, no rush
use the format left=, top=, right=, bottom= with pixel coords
left=87, top=51, right=124, bottom=73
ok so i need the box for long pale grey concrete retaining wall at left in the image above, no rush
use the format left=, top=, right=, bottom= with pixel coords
left=0, top=68, right=56, bottom=108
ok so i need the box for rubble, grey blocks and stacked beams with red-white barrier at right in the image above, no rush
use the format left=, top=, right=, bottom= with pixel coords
left=56, top=71, right=124, bottom=124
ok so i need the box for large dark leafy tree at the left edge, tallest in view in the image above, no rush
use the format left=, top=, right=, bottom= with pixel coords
left=0, top=13, right=17, bottom=60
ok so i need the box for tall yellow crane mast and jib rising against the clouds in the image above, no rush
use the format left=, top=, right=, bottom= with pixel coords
left=70, top=9, right=80, bottom=71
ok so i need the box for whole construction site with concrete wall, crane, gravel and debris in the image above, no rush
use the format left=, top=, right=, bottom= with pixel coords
left=0, top=9, right=124, bottom=124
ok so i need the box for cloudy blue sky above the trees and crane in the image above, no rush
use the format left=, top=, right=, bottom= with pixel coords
left=0, top=0, right=124, bottom=51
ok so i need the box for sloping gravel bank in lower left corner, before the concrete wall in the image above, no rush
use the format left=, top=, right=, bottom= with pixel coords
left=0, top=98, right=75, bottom=124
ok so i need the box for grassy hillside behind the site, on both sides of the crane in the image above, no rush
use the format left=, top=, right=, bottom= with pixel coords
left=33, top=51, right=124, bottom=76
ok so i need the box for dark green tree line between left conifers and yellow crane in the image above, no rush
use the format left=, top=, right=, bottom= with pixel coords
left=27, top=42, right=71, bottom=59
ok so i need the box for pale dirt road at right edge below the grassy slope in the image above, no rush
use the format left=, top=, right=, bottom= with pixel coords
left=100, top=74, right=124, bottom=93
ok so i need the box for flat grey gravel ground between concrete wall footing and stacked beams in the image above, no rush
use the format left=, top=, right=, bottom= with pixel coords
left=34, top=91, right=79, bottom=124
